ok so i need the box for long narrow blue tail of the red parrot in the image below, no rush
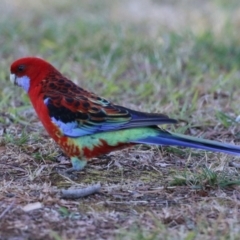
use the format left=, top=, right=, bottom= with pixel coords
left=134, top=130, right=240, bottom=155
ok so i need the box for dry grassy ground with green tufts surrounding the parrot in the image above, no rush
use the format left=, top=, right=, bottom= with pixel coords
left=0, top=0, right=240, bottom=240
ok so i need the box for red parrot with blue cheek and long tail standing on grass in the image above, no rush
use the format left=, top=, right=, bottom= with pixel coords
left=10, top=57, right=240, bottom=173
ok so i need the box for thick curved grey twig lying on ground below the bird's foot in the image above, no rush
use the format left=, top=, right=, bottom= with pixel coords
left=61, top=183, right=101, bottom=199
